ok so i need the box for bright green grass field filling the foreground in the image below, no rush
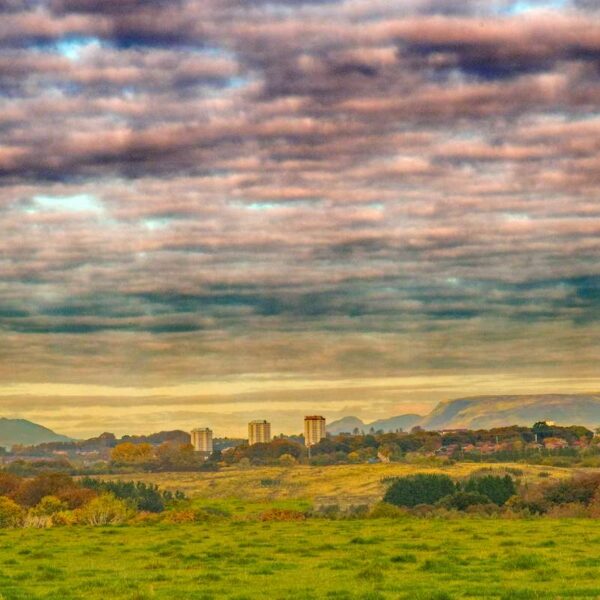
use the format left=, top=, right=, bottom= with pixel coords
left=0, top=518, right=600, bottom=600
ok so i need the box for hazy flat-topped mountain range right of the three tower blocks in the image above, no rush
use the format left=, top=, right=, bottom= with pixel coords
left=327, top=394, right=600, bottom=435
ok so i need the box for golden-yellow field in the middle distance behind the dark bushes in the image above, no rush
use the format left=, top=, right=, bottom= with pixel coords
left=106, top=463, right=573, bottom=502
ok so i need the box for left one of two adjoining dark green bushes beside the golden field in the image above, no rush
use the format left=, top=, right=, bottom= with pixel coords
left=383, top=473, right=456, bottom=508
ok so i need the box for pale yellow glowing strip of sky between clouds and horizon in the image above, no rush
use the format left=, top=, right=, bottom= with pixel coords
left=0, top=373, right=600, bottom=437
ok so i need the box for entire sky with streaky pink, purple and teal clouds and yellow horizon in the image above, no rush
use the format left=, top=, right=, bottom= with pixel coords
left=0, top=0, right=600, bottom=437
